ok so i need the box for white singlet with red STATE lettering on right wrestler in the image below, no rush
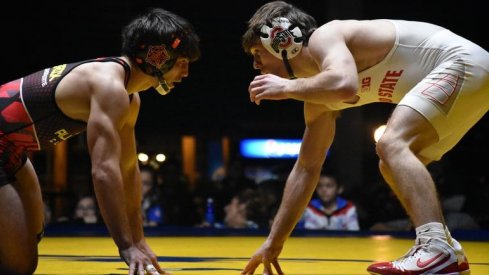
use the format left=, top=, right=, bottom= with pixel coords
left=327, top=20, right=489, bottom=160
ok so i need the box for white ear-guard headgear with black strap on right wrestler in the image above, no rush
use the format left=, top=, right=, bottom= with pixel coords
left=260, top=17, right=303, bottom=79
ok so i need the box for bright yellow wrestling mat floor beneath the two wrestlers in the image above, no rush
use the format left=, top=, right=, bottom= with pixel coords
left=35, top=236, right=489, bottom=275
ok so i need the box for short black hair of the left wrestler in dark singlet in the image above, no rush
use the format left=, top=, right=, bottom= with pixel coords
left=121, top=8, right=200, bottom=61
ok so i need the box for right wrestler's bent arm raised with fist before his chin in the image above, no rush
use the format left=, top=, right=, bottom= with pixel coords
left=249, top=23, right=358, bottom=104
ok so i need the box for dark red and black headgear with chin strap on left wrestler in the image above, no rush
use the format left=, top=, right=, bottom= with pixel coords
left=135, top=38, right=180, bottom=95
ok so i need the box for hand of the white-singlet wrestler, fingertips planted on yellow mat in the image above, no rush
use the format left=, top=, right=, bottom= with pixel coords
left=241, top=241, right=284, bottom=275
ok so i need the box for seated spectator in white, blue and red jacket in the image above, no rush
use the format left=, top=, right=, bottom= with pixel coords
left=297, top=174, right=360, bottom=230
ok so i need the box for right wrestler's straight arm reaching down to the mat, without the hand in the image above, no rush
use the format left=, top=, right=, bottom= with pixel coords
left=268, top=103, right=336, bottom=246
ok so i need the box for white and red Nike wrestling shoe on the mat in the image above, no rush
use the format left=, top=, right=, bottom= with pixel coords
left=367, top=239, right=470, bottom=275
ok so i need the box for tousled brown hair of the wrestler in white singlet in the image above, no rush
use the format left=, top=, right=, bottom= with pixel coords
left=241, top=1, right=317, bottom=53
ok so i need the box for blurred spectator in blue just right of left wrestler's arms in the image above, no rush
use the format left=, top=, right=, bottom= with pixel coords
left=140, top=166, right=163, bottom=229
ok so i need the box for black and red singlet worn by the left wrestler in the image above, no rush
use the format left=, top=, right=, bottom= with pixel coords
left=0, top=57, right=130, bottom=186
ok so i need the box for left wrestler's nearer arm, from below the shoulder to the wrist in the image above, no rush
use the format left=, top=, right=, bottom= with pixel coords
left=87, top=84, right=133, bottom=249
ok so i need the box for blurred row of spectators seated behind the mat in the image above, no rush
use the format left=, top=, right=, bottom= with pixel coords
left=45, top=157, right=489, bottom=231
